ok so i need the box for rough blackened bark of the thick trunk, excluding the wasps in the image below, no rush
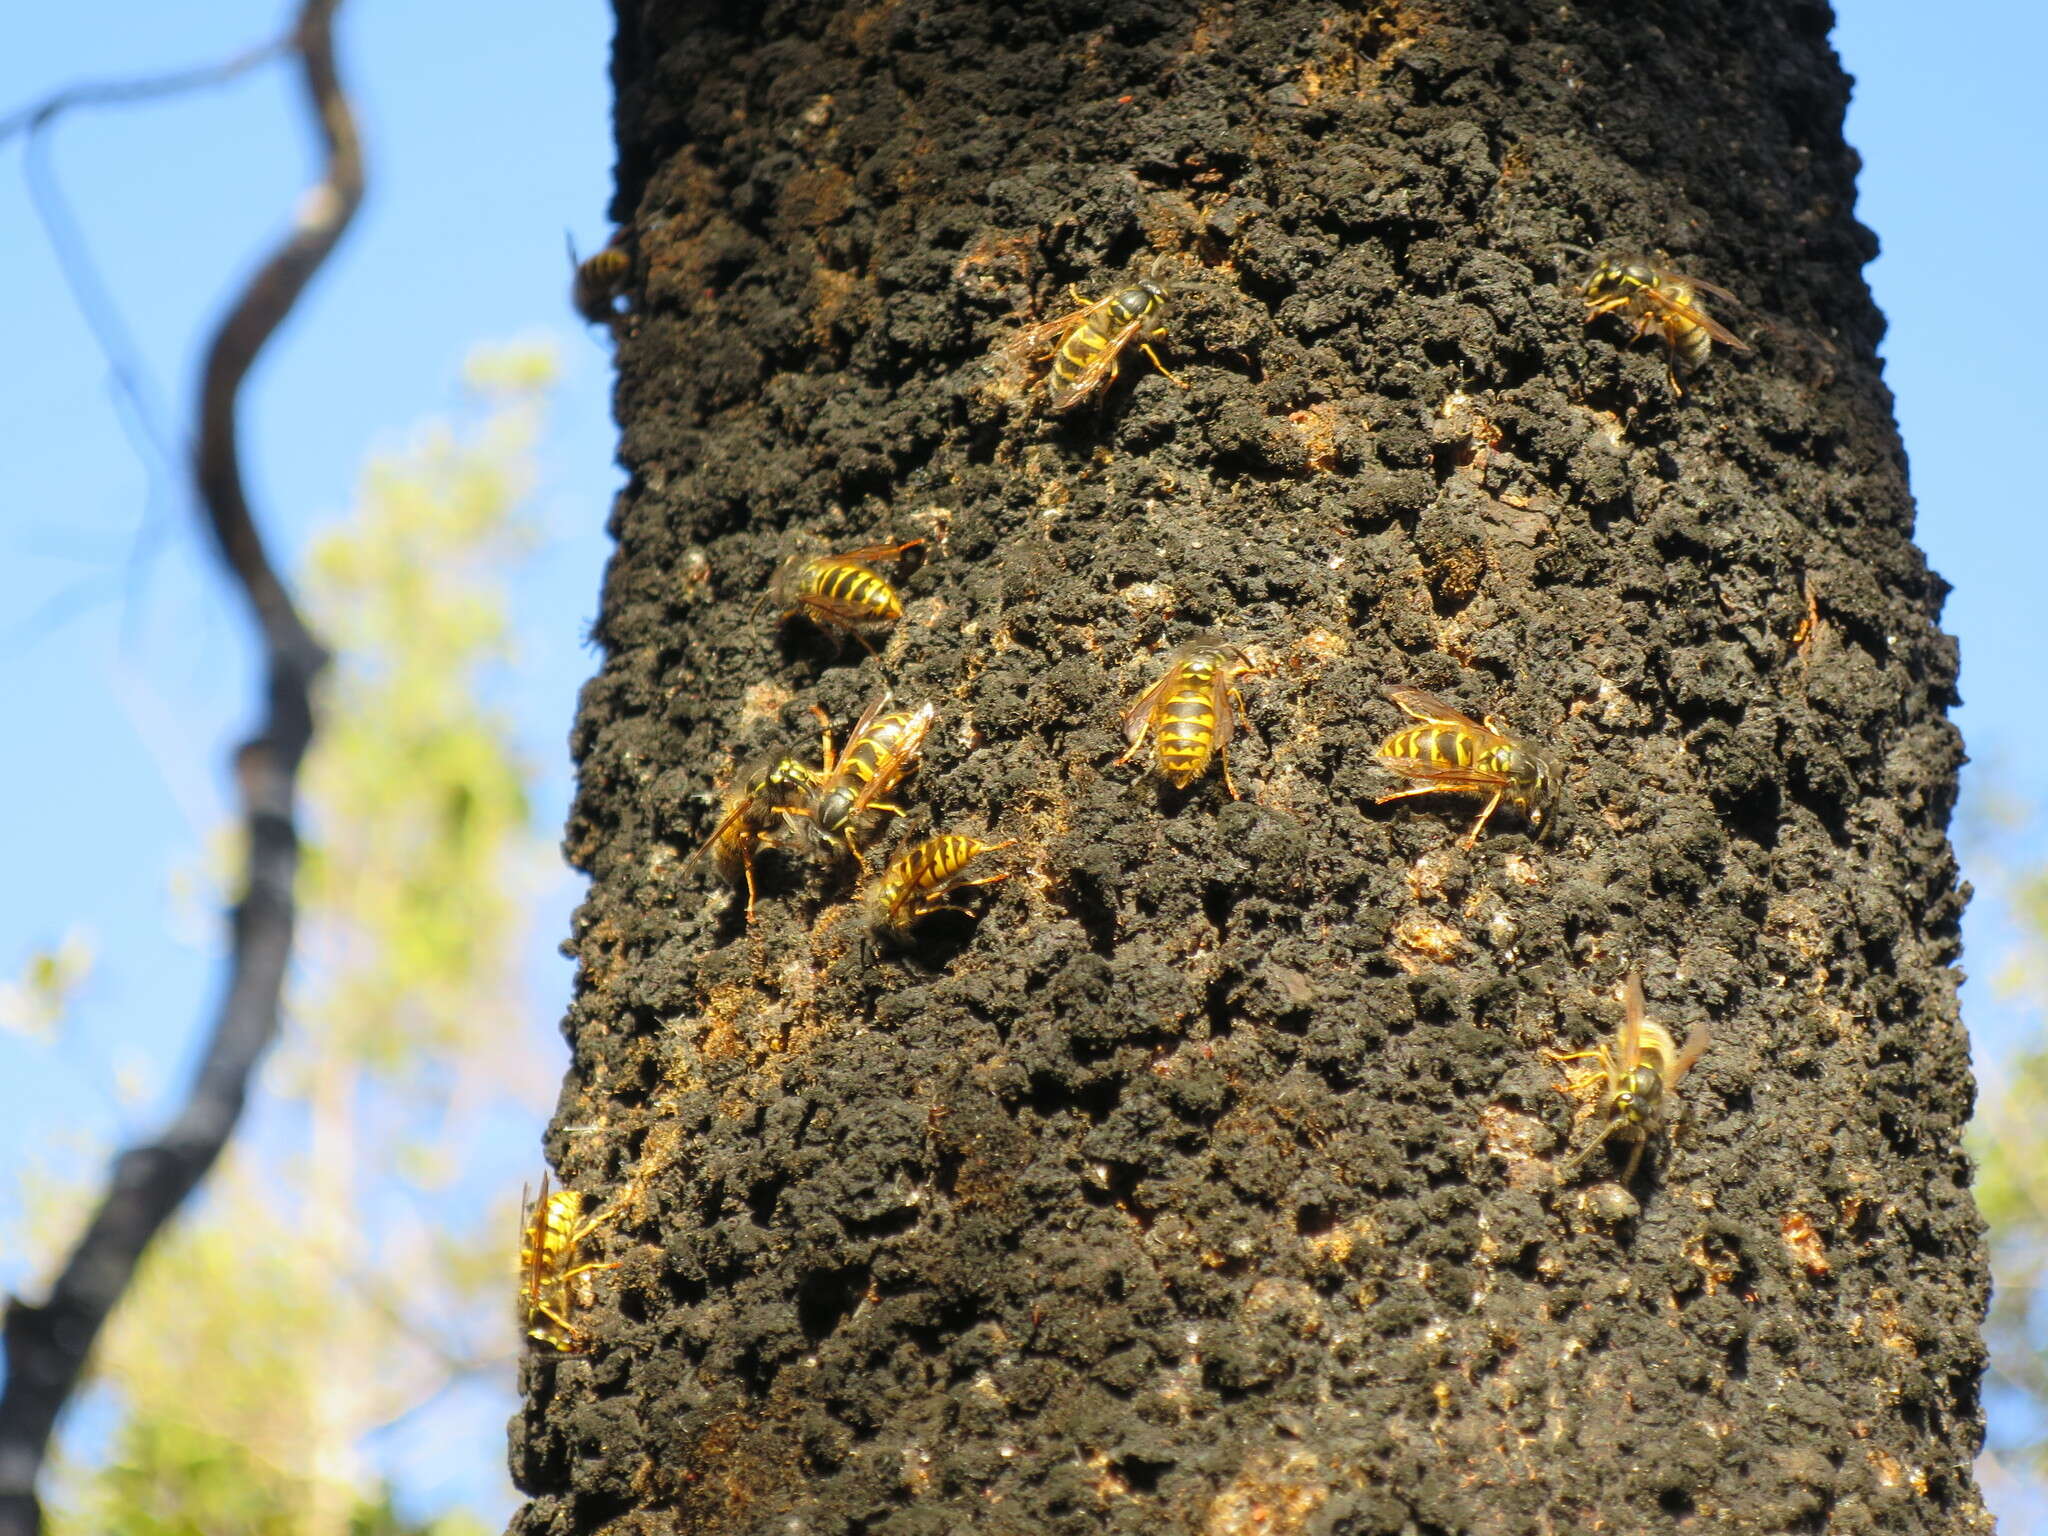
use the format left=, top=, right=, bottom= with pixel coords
left=512, top=0, right=1989, bottom=1536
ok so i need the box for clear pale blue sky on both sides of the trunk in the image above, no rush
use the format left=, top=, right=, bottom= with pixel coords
left=0, top=0, right=2048, bottom=1524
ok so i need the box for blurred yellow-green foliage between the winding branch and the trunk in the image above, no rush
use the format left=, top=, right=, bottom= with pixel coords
left=44, top=350, right=553, bottom=1536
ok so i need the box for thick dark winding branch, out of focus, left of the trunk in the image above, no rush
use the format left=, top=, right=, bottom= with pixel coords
left=0, top=0, right=362, bottom=1536
